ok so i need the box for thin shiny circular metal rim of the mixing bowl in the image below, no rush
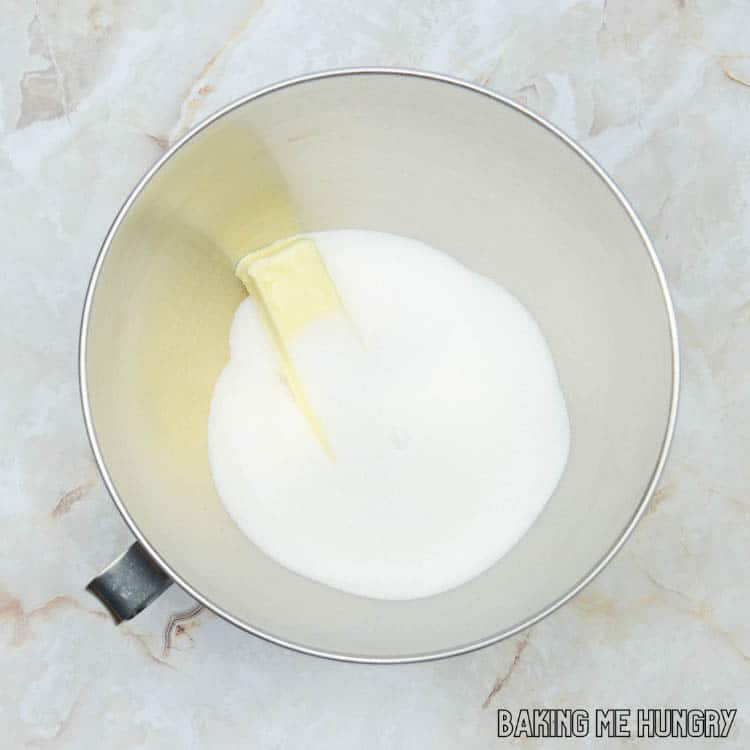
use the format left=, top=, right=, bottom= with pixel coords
left=78, top=67, right=680, bottom=664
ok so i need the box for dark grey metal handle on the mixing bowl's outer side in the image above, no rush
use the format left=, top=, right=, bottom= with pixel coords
left=86, top=542, right=172, bottom=625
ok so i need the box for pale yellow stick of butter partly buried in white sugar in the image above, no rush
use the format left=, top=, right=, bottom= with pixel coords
left=235, top=237, right=345, bottom=457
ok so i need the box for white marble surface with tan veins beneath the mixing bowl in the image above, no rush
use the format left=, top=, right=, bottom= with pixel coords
left=0, top=0, right=750, bottom=748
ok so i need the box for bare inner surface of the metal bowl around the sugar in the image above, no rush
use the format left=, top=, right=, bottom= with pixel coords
left=84, top=72, right=674, bottom=659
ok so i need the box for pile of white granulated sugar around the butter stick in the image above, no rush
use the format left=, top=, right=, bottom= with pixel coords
left=208, top=230, right=569, bottom=599
